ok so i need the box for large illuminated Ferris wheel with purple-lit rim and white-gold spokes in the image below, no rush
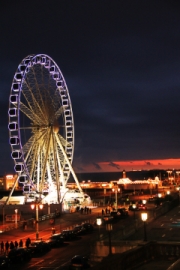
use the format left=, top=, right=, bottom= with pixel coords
left=8, top=54, right=82, bottom=202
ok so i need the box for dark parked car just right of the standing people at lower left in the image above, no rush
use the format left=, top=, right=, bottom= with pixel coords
left=28, top=240, right=51, bottom=257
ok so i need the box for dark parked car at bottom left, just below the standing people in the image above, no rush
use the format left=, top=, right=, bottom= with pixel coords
left=8, top=247, right=32, bottom=263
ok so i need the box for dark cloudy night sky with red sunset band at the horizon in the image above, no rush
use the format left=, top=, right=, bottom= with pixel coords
left=0, top=0, right=180, bottom=175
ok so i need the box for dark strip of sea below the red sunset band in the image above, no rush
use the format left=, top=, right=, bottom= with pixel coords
left=68, top=170, right=168, bottom=182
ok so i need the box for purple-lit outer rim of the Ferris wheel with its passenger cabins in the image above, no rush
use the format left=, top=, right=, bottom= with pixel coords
left=9, top=54, right=74, bottom=194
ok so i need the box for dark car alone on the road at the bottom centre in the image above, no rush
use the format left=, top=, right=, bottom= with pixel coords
left=69, top=255, right=90, bottom=270
